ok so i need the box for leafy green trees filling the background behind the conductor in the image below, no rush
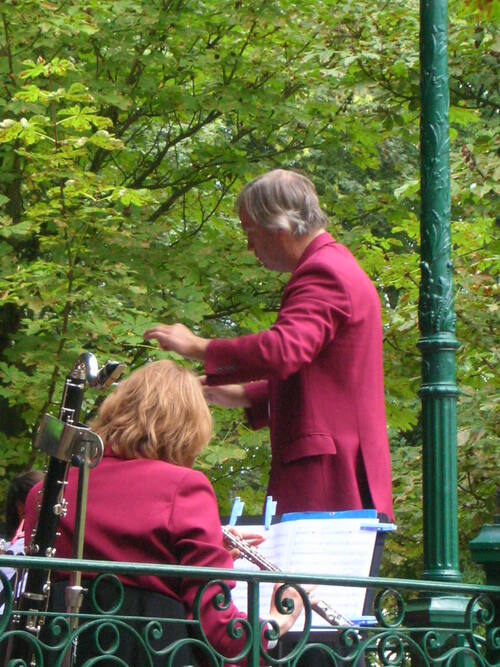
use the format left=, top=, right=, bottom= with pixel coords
left=0, top=0, right=500, bottom=580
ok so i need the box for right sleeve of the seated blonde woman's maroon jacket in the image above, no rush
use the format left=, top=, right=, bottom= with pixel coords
left=166, top=470, right=264, bottom=658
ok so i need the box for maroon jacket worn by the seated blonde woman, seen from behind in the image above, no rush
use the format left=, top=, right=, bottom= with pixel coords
left=25, top=450, right=250, bottom=656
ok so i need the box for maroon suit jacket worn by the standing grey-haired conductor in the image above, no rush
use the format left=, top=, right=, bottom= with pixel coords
left=205, top=232, right=393, bottom=518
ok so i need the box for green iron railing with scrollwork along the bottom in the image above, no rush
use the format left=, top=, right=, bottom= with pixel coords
left=0, top=556, right=500, bottom=667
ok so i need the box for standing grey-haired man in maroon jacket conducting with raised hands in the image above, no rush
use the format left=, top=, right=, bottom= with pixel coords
left=144, top=169, right=393, bottom=518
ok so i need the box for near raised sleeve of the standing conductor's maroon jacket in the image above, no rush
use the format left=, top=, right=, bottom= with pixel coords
left=205, top=264, right=351, bottom=385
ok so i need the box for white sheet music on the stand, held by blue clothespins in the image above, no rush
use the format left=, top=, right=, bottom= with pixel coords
left=233, top=518, right=378, bottom=628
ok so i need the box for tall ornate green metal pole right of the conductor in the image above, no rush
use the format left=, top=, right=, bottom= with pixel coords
left=418, top=0, right=461, bottom=582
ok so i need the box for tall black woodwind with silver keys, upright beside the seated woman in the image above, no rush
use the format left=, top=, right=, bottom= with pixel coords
left=4, top=352, right=125, bottom=665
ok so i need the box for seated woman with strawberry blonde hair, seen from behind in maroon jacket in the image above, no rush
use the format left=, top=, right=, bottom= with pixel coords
left=26, top=360, right=302, bottom=657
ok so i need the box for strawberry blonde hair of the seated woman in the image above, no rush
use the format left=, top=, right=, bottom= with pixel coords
left=89, top=360, right=212, bottom=467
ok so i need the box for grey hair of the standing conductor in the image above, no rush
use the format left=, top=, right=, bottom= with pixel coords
left=235, top=169, right=328, bottom=236
